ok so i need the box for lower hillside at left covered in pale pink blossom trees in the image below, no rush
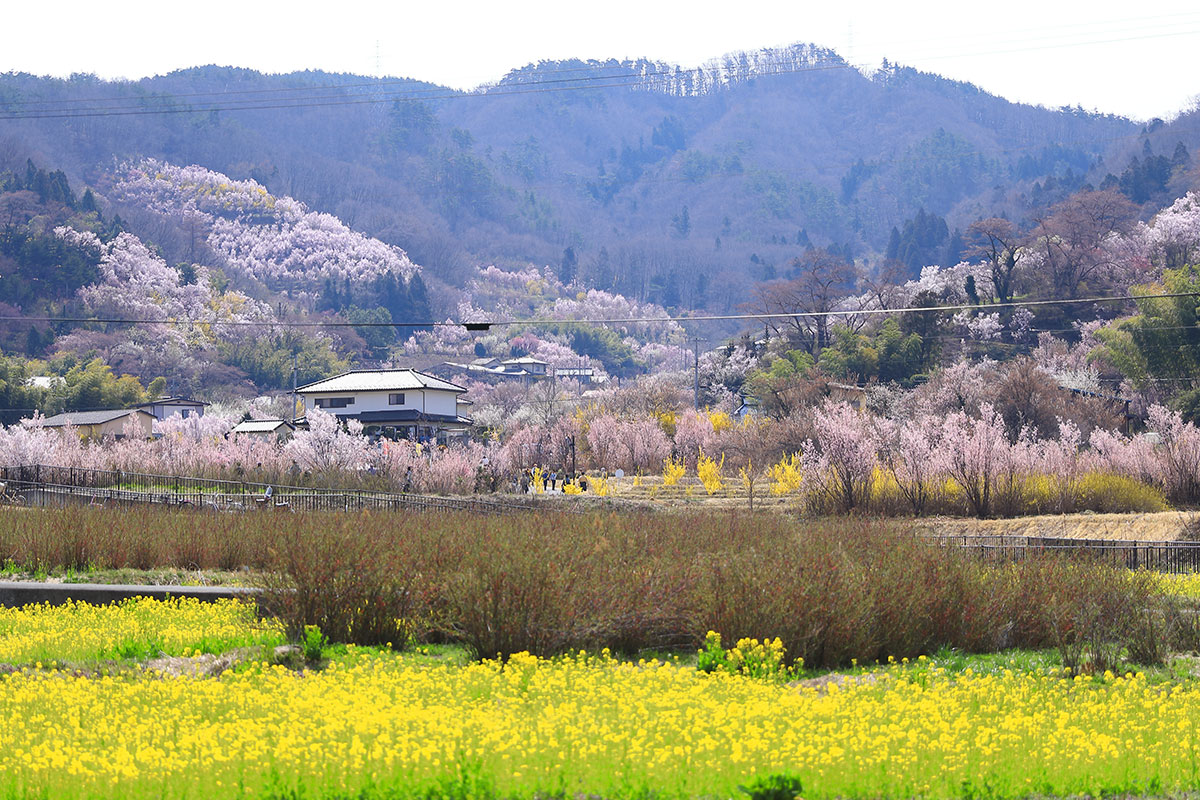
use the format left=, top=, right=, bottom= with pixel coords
left=0, top=160, right=431, bottom=402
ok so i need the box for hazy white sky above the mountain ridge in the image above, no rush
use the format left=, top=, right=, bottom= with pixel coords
left=9, top=0, right=1200, bottom=119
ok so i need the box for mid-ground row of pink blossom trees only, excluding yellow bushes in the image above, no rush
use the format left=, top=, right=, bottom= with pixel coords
left=9, top=401, right=1200, bottom=506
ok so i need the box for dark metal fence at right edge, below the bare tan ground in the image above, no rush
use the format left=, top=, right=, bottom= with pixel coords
left=931, top=535, right=1200, bottom=575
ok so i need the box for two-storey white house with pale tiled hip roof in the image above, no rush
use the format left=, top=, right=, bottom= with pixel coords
left=296, top=369, right=472, bottom=440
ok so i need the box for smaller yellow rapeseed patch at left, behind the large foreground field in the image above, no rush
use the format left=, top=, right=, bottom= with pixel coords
left=0, top=597, right=283, bottom=664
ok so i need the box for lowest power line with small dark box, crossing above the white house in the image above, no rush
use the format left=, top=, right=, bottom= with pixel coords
left=0, top=291, right=1200, bottom=332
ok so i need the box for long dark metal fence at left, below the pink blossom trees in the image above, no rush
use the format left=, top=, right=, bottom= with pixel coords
left=0, top=464, right=538, bottom=513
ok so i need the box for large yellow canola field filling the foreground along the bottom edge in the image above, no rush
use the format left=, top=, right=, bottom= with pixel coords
left=0, top=642, right=1200, bottom=800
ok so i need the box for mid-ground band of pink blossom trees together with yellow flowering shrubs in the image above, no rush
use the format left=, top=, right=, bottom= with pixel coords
left=0, top=393, right=1200, bottom=517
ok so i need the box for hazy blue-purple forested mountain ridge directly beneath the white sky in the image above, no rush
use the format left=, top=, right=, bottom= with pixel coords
left=0, top=46, right=1180, bottom=309
